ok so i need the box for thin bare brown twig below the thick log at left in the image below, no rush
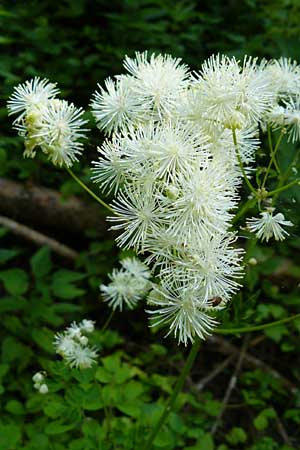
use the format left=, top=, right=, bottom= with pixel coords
left=0, top=216, right=79, bottom=261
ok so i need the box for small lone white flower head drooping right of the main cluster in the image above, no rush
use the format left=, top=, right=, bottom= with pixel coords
left=247, top=208, right=293, bottom=242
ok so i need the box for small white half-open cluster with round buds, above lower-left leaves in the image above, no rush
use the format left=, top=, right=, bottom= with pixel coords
left=54, top=319, right=98, bottom=369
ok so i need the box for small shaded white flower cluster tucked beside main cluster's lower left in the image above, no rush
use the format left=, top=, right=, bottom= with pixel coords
left=100, top=258, right=151, bottom=311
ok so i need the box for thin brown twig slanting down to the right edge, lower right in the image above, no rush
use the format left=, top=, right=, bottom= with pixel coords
left=209, top=336, right=297, bottom=394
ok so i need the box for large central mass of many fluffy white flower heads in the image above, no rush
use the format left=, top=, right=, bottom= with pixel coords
left=92, top=53, right=282, bottom=344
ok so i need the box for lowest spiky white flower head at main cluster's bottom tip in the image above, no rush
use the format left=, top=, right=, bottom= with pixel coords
left=148, top=286, right=217, bottom=345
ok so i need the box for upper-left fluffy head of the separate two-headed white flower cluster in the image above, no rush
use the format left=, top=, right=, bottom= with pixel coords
left=7, top=77, right=59, bottom=121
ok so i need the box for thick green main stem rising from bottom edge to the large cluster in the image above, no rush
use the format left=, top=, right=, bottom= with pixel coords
left=143, top=339, right=200, bottom=450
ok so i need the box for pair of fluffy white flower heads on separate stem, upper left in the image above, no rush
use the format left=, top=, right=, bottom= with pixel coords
left=7, top=77, right=86, bottom=167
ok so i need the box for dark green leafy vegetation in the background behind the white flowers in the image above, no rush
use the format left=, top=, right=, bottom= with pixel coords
left=0, top=0, right=300, bottom=450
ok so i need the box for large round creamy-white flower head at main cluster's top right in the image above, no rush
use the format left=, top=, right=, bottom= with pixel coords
left=193, top=55, right=274, bottom=128
